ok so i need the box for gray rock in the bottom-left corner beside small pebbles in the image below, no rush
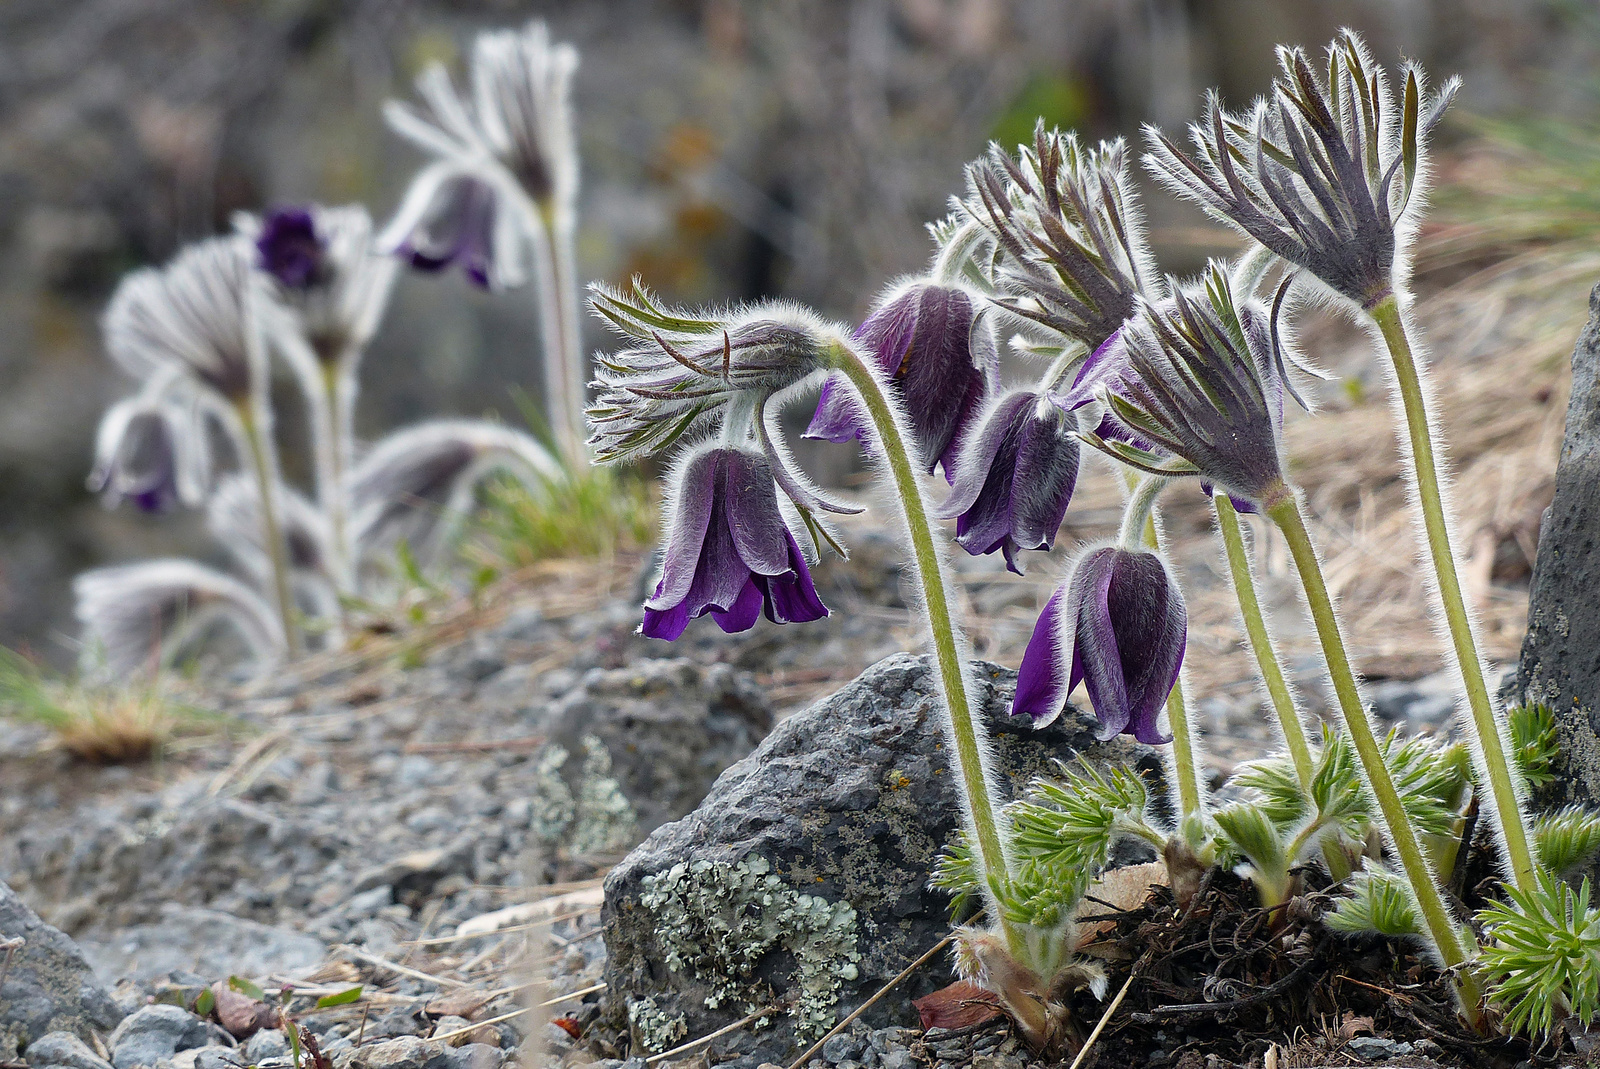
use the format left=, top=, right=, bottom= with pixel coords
left=0, top=883, right=122, bottom=1047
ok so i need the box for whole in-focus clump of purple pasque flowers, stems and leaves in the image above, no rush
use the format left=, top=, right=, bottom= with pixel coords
left=589, top=32, right=1600, bottom=1045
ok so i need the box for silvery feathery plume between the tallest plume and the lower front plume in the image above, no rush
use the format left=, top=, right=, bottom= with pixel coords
left=936, top=120, right=1162, bottom=352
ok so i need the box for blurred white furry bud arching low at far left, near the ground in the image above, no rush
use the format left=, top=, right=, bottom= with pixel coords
left=72, top=560, right=283, bottom=675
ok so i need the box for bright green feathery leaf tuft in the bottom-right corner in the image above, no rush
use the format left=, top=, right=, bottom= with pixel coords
left=1478, top=872, right=1600, bottom=1037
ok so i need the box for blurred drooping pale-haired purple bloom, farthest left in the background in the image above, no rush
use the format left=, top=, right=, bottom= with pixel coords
left=88, top=381, right=211, bottom=512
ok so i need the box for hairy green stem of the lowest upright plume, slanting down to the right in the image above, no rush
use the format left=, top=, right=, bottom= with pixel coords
left=1267, top=488, right=1483, bottom=1026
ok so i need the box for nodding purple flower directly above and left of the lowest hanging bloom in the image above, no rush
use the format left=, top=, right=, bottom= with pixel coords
left=938, top=390, right=1078, bottom=575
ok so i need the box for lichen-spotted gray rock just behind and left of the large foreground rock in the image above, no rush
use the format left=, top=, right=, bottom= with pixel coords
left=542, top=659, right=773, bottom=832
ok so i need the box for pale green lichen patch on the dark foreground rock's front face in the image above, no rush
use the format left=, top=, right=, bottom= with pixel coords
left=640, top=856, right=861, bottom=1037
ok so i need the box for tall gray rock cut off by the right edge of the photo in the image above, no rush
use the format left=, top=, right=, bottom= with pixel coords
left=1514, top=286, right=1600, bottom=805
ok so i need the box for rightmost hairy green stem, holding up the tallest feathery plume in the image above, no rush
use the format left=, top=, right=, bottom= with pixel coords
left=1371, top=296, right=1536, bottom=891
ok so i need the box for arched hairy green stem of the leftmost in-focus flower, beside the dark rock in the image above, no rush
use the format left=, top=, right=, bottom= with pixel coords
left=829, top=341, right=1027, bottom=962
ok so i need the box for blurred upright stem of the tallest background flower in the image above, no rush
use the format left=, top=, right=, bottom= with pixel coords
left=533, top=200, right=589, bottom=474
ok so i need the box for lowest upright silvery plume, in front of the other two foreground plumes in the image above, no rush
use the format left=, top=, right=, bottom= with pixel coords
left=1083, top=262, right=1286, bottom=504
